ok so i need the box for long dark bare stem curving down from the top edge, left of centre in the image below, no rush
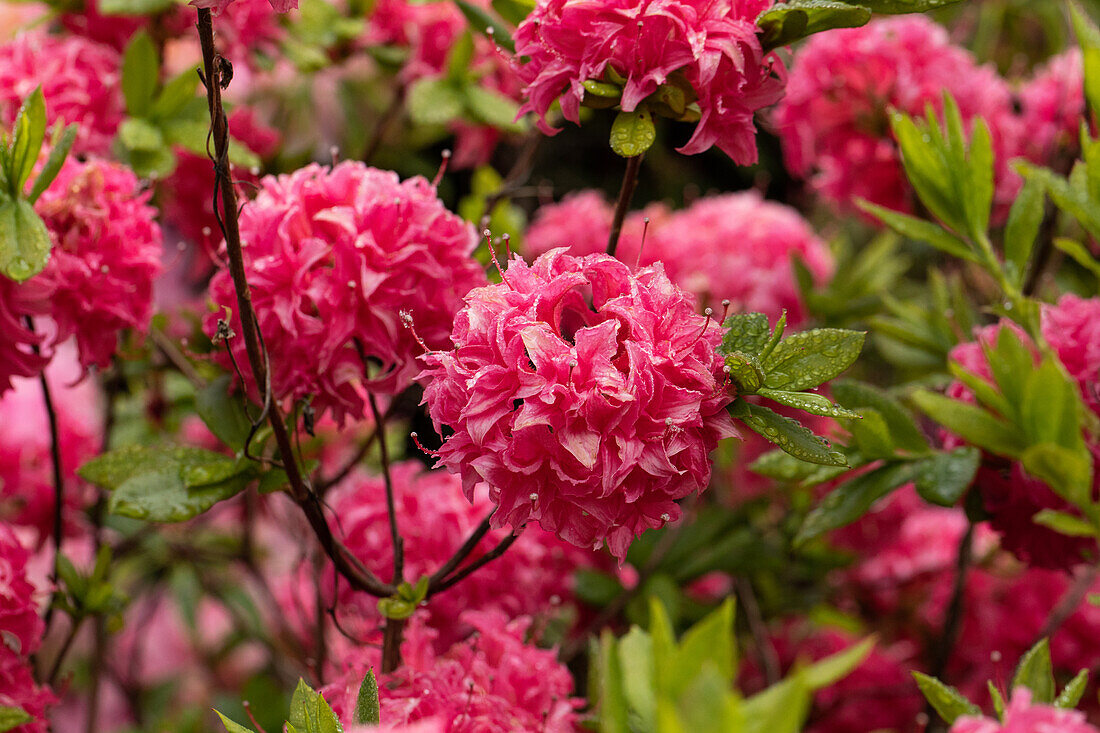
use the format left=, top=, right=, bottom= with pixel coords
left=197, top=8, right=395, bottom=597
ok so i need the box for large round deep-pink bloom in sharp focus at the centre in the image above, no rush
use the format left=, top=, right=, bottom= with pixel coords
left=418, top=250, right=735, bottom=559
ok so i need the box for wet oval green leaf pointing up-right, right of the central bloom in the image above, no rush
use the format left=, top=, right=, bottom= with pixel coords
left=762, top=328, right=867, bottom=392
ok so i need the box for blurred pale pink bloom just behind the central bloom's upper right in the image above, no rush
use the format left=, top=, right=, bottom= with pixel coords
left=642, top=192, right=833, bottom=319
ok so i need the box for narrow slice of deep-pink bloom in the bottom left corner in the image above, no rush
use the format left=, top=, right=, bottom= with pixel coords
left=0, top=524, right=54, bottom=733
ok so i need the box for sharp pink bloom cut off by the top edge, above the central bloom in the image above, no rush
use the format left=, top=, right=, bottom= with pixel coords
left=515, top=0, right=785, bottom=165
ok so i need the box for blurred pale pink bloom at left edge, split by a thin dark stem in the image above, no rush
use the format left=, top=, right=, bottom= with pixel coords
left=0, top=344, right=102, bottom=544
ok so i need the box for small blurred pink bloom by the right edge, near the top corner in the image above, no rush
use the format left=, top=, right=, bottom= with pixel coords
left=1020, top=47, right=1085, bottom=165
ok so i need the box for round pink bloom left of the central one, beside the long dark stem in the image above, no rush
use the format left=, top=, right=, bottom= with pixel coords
left=205, top=162, right=485, bottom=423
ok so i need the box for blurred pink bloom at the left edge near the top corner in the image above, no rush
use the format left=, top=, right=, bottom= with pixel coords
left=0, top=31, right=124, bottom=157
